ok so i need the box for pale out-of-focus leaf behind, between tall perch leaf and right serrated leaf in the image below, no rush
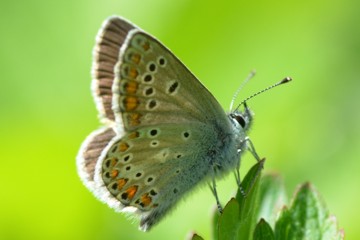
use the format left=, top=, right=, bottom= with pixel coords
left=256, top=174, right=287, bottom=227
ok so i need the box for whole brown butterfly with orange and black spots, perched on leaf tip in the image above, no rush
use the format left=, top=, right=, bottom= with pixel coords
left=77, top=16, right=292, bottom=231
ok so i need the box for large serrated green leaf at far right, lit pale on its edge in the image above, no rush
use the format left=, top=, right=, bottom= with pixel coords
left=275, top=183, right=343, bottom=240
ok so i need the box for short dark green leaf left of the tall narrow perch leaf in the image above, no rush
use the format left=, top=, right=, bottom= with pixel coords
left=218, top=198, right=239, bottom=240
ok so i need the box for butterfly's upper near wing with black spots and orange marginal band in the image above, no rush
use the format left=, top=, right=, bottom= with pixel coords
left=113, top=29, right=227, bottom=130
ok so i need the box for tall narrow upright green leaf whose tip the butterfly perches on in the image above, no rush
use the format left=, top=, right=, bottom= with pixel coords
left=236, top=160, right=265, bottom=239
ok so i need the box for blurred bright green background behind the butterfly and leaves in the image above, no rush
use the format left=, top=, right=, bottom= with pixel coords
left=0, top=0, right=360, bottom=239
